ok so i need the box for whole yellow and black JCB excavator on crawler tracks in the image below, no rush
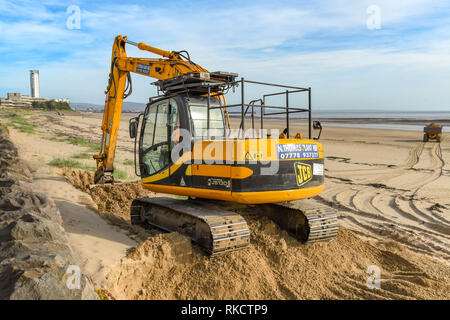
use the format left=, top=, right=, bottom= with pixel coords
left=94, top=36, right=338, bottom=256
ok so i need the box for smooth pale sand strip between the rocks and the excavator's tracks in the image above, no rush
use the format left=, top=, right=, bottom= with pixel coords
left=23, top=175, right=137, bottom=287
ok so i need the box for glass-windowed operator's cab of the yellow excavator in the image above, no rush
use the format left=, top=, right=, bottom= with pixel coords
left=133, top=95, right=226, bottom=183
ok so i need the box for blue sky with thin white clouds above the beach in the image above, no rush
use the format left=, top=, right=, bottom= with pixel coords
left=0, top=0, right=450, bottom=111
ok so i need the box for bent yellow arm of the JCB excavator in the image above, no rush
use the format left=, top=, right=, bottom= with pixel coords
left=94, top=36, right=208, bottom=184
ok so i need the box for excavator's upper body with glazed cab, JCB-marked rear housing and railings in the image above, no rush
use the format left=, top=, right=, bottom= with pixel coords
left=130, top=72, right=324, bottom=204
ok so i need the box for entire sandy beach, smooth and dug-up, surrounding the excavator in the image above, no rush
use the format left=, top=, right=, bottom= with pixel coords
left=1, top=113, right=450, bottom=299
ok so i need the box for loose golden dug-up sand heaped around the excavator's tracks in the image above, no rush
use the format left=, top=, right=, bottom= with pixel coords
left=61, top=171, right=450, bottom=299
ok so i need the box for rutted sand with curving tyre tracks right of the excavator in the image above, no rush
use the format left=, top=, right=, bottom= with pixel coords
left=318, top=142, right=450, bottom=258
